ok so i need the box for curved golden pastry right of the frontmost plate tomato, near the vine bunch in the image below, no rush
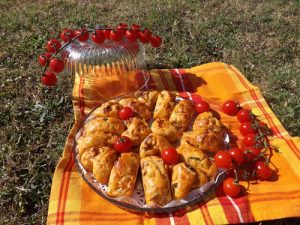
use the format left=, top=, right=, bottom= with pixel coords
left=177, top=145, right=217, bottom=187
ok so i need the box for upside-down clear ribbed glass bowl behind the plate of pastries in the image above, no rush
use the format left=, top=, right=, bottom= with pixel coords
left=62, top=38, right=149, bottom=102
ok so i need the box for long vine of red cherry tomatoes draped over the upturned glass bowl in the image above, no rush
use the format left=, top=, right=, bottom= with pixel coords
left=38, top=23, right=162, bottom=86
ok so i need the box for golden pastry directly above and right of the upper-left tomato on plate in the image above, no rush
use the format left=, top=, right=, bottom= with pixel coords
left=119, top=98, right=151, bottom=120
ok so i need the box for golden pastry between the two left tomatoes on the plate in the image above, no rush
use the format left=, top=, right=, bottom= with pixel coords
left=122, top=117, right=151, bottom=146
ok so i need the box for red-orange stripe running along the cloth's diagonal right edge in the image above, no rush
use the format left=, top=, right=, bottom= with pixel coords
left=229, top=65, right=300, bottom=159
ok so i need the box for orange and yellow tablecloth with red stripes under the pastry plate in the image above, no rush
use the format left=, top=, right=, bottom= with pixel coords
left=47, top=63, right=300, bottom=225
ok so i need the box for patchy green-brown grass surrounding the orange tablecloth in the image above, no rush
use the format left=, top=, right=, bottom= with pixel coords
left=0, top=0, right=300, bottom=224
